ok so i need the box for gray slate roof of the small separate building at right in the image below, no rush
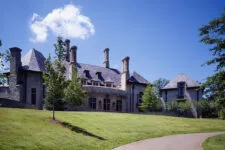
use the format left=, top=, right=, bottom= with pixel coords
left=162, top=73, right=200, bottom=90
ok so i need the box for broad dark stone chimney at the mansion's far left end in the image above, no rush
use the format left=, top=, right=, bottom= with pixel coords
left=9, top=47, right=22, bottom=76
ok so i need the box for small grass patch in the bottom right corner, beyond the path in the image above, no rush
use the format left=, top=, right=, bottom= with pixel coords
left=203, top=134, right=225, bottom=150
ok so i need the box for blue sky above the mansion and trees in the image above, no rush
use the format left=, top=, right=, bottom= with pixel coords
left=0, top=0, right=225, bottom=82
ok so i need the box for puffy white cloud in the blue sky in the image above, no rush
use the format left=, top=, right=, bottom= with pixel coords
left=30, top=4, right=95, bottom=42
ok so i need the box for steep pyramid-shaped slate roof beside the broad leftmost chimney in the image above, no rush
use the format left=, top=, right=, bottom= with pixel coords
left=22, top=49, right=46, bottom=72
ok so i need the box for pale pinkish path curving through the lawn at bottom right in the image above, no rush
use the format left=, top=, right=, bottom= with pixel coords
left=113, top=132, right=225, bottom=150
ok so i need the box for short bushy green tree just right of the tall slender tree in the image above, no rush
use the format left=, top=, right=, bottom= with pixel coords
left=65, top=66, right=87, bottom=106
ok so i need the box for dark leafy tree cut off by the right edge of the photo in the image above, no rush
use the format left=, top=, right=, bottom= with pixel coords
left=199, top=9, right=225, bottom=119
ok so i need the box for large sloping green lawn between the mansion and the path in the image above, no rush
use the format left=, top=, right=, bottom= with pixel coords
left=0, top=108, right=225, bottom=150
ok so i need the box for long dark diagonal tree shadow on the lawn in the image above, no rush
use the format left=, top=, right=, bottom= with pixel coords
left=61, top=122, right=105, bottom=140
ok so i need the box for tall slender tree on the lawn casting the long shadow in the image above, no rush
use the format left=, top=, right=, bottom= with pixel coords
left=43, top=37, right=66, bottom=120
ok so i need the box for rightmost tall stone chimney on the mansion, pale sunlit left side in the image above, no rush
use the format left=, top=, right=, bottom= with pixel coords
left=121, top=56, right=130, bottom=91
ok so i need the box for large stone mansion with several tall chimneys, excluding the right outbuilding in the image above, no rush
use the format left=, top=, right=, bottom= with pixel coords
left=0, top=40, right=149, bottom=112
